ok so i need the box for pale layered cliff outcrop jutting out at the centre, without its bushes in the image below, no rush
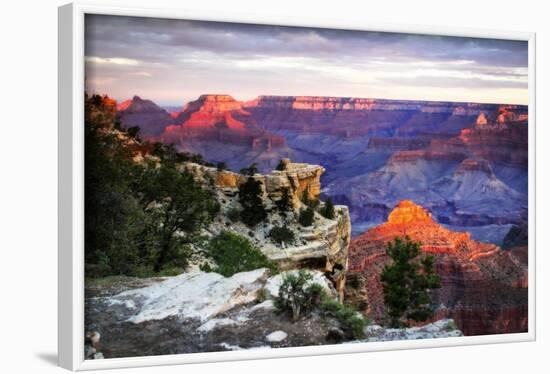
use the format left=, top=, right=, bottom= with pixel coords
left=183, top=160, right=351, bottom=298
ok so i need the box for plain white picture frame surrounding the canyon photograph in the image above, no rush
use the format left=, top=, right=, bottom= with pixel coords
left=58, top=2, right=536, bottom=371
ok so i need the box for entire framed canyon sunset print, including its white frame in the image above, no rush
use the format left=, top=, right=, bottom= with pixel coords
left=59, top=3, right=535, bottom=370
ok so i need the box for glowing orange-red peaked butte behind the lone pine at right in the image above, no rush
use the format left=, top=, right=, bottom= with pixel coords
left=350, top=201, right=527, bottom=335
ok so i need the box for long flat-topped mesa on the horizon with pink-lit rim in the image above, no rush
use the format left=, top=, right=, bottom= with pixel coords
left=243, top=96, right=524, bottom=136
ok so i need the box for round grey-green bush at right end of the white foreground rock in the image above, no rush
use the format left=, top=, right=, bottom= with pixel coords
left=275, top=269, right=324, bottom=322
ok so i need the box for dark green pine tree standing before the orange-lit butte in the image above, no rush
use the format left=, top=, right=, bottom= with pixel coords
left=380, top=237, right=441, bottom=327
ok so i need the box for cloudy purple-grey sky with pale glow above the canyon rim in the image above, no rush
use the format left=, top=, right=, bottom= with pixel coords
left=85, top=15, right=528, bottom=106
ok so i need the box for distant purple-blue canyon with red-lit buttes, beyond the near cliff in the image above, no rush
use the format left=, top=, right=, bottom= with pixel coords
left=118, top=95, right=528, bottom=244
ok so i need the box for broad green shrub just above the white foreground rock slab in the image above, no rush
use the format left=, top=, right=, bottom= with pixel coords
left=206, top=231, right=276, bottom=277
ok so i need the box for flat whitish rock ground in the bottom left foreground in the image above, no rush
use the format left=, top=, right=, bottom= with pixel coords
left=86, top=269, right=348, bottom=358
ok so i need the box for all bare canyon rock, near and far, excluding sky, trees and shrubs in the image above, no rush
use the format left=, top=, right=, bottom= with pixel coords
left=85, top=95, right=528, bottom=358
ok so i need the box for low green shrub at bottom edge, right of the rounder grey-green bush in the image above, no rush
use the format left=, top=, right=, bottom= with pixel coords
left=319, top=297, right=368, bottom=339
